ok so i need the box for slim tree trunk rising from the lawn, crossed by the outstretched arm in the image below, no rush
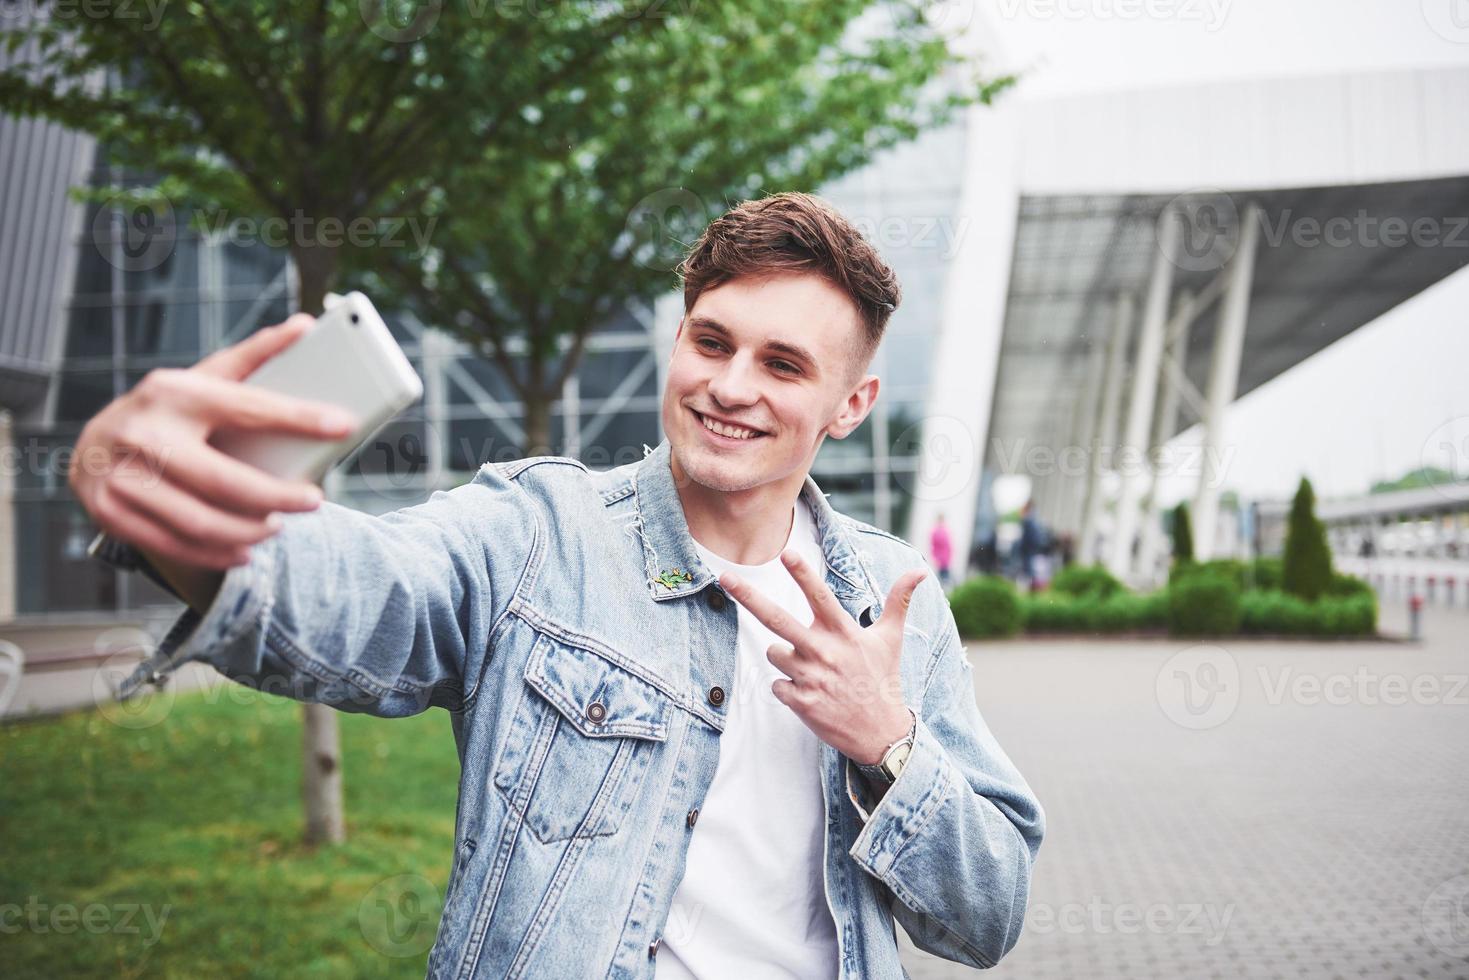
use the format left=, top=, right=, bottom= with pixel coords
left=291, top=241, right=347, bottom=846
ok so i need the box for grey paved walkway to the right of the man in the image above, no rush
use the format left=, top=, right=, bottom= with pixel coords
left=899, top=602, right=1469, bottom=980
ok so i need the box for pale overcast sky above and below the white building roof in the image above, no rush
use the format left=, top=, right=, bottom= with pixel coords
left=981, top=0, right=1469, bottom=504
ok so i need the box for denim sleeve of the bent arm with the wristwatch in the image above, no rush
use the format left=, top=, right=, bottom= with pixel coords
left=846, top=614, right=1044, bottom=968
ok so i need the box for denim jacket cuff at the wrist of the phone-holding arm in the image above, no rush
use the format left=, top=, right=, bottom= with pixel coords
left=87, top=532, right=276, bottom=701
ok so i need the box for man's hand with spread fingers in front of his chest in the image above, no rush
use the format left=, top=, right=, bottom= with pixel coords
left=720, top=550, right=928, bottom=765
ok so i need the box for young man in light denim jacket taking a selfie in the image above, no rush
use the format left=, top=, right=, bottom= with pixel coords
left=72, top=194, right=1043, bottom=980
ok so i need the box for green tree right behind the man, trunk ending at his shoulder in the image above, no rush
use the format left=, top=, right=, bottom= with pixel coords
left=354, top=0, right=1012, bottom=454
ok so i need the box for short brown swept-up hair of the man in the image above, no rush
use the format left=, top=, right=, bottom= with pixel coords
left=679, top=192, right=902, bottom=364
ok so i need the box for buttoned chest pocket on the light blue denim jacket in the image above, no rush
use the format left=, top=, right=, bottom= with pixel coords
left=494, top=635, right=670, bottom=843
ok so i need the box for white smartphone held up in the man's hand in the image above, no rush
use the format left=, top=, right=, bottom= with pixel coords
left=210, top=291, right=423, bottom=483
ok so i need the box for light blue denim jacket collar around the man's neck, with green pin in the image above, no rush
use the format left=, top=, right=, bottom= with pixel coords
left=633, top=438, right=878, bottom=614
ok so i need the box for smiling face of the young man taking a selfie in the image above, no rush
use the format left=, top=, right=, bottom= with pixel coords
left=663, top=275, right=878, bottom=492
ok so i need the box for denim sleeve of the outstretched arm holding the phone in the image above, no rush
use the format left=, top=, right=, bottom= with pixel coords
left=91, top=464, right=536, bottom=717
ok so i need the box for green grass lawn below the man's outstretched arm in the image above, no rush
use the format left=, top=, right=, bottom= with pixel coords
left=0, top=685, right=458, bottom=980
